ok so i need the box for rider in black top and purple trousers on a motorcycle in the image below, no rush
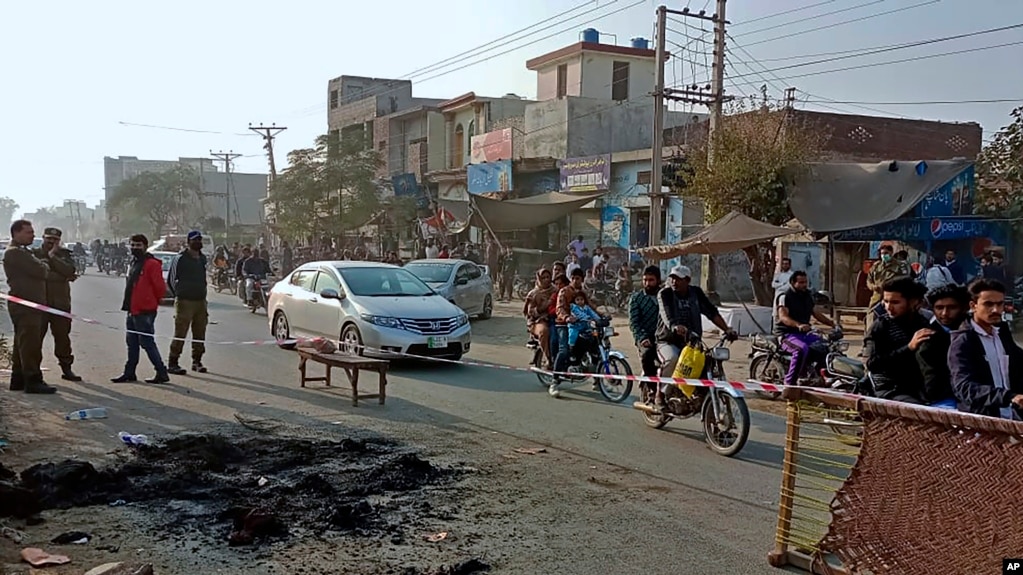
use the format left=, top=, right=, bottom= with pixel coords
left=774, top=270, right=835, bottom=386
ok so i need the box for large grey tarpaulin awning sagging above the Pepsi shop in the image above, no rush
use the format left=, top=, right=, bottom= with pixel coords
left=789, top=160, right=972, bottom=232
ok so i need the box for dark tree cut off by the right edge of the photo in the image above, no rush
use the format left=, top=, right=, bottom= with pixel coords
left=974, top=106, right=1023, bottom=227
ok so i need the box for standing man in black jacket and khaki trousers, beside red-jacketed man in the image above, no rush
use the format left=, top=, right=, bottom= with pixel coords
left=167, top=230, right=210, bottom=375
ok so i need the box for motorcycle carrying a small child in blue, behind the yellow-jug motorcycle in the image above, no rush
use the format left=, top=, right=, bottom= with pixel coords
left=526, top=318, right=632, bottom=403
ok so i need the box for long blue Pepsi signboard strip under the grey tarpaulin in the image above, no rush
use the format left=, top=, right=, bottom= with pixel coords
left=831, top=217, right=997, bottom=241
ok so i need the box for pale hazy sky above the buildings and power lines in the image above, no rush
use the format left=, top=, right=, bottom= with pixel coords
left=0, top=0, right=1023, bottom=211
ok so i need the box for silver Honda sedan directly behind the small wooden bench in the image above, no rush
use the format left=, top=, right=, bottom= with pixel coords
left=267, top=261, right=472, bottom=359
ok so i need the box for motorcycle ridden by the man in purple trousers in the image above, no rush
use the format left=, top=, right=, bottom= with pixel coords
left=750, top=327, right=866, bottom=399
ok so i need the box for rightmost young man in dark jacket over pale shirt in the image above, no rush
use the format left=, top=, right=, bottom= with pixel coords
left=948, top=278, right=1023, bottom=421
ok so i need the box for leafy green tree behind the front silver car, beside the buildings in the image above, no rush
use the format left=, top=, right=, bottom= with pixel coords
left=268, top=136, right=383, bottom=240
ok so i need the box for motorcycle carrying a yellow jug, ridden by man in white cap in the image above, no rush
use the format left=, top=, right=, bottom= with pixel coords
left=632, top=336, right=750, bottom=457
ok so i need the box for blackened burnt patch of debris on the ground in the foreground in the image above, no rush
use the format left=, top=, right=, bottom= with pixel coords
left=0, top=434, right=462, bottom=545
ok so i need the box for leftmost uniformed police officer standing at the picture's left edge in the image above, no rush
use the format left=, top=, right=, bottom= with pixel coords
left=3, top=220, right=57, bottom=393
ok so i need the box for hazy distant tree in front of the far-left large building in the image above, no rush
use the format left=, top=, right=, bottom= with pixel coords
left=109, top=166, right=204, bottom=237
